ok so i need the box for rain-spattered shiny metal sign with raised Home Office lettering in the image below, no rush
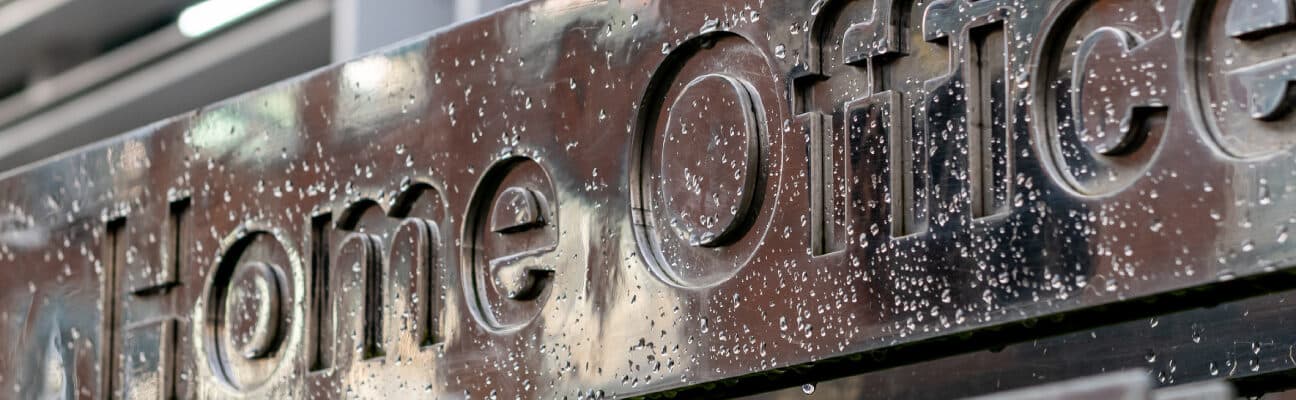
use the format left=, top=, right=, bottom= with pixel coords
left=10, top=0, right=1296, bottom=399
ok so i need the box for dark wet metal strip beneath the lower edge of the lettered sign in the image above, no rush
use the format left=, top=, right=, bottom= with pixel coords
left=744, top=282, right=1296, bottom=400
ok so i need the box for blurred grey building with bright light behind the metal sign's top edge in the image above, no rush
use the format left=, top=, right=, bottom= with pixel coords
left=0, top=0, right=516, bottom=173
